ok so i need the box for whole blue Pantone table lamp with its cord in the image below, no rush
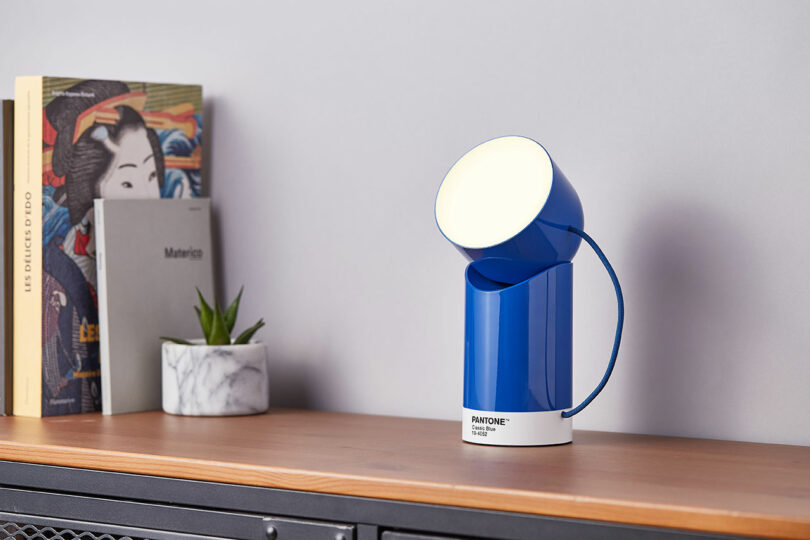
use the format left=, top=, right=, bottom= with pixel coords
left=436, top=136, right=624, bottom=446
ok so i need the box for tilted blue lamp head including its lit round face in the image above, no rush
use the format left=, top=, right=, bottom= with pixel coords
left=435, top=136, right=583, bottom=284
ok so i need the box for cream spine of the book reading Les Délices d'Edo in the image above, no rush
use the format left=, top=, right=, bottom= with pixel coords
left=13, top=77, right=43, bottom=416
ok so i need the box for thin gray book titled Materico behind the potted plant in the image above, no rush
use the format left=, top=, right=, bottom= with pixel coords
left=95, top=199, right=214, bottom=414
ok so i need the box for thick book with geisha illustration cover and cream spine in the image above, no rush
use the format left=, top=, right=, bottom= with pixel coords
left=13, top=77, right=203, bottom=416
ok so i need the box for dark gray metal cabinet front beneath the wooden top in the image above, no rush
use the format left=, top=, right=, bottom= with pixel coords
left=0, top=461, right=740, bottom=540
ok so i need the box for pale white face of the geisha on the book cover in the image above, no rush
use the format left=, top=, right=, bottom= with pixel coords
left=92, top=126, right=160, bottom=199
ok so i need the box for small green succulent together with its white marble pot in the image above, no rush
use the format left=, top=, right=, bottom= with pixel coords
left=161, top=287, right=269, bottom=416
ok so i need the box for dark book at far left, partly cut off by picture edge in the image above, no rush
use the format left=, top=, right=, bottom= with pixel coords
left=0, top=99, right=14, bottom=415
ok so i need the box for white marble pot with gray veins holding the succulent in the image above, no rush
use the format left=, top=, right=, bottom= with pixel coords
left=162, top=342, right=269, bottom=416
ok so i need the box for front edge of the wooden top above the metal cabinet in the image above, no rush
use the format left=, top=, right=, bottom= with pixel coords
left=0, top=442, right=810, bottom=539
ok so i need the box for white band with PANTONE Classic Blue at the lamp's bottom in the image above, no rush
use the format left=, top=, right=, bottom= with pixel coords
left=461, top=408, right=573, bottom=446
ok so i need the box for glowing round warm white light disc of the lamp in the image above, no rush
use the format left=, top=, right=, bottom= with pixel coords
left=436, top=136, right=554, bottom=249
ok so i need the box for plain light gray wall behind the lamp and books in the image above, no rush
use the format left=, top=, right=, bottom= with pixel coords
left=0, top=0, right=810, bottom=445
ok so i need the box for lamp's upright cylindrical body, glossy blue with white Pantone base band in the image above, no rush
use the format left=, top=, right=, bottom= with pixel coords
left=463, top=262, right=573, bottom=446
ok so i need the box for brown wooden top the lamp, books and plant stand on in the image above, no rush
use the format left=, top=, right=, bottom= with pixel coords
left=0, top=409, right=810, bottom=538
